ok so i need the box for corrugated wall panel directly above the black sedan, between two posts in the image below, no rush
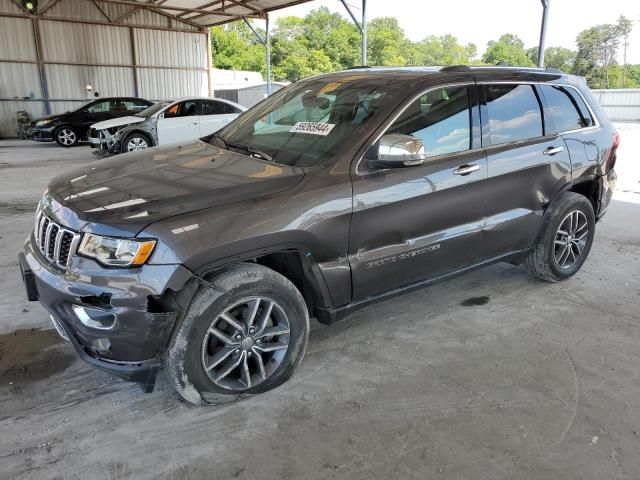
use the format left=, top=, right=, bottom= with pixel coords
left=45, top=65, right=135, bottom=100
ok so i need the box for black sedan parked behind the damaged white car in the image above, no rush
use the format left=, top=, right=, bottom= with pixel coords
left=31, top=97, right=153, bottom=147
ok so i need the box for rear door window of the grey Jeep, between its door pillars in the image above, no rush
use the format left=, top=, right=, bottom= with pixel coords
left=485, top=85, right=544, bottom=145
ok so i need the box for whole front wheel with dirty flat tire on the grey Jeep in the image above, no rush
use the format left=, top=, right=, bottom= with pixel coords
left=165, top=264, right=309, bottom=405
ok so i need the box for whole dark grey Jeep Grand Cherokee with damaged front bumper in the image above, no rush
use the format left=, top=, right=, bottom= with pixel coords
left=20, top=67, right=619, bottom=403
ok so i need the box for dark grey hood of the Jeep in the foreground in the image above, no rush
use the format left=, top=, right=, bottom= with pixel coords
left=42, top=140, right=304, bottom=236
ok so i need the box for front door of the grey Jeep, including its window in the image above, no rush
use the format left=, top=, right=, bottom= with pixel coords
left=349, top=85, right=487, bottom=301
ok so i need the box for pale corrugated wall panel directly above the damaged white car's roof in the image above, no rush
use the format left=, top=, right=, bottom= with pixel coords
left=138, top=68, right=208, bottom=100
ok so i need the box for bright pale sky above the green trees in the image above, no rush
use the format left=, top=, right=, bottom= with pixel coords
left=271, top=0, right=640, bottom=64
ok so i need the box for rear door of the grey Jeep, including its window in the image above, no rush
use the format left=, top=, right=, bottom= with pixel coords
left=481, top=82, right=571, bottom=258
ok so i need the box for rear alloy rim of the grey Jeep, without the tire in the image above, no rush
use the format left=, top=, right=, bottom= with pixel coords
left=553, top=210, right=589, bottom=270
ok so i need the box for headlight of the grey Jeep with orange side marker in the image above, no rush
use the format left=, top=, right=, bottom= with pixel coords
left=78, top=233, right=156, bottom=267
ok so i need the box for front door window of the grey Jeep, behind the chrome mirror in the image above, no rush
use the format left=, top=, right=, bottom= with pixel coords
left=387, top=87, right=471, bottom=157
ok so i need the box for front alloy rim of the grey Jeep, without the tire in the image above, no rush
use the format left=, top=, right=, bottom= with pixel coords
left=202, top=297, right=289, bottom=390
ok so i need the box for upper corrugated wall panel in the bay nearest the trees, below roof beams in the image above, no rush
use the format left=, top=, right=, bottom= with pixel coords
left=134, top=28, right=207, bottom=68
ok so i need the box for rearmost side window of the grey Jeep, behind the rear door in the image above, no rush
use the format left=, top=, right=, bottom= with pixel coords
left=540, top=85, right=593, bottom=132
